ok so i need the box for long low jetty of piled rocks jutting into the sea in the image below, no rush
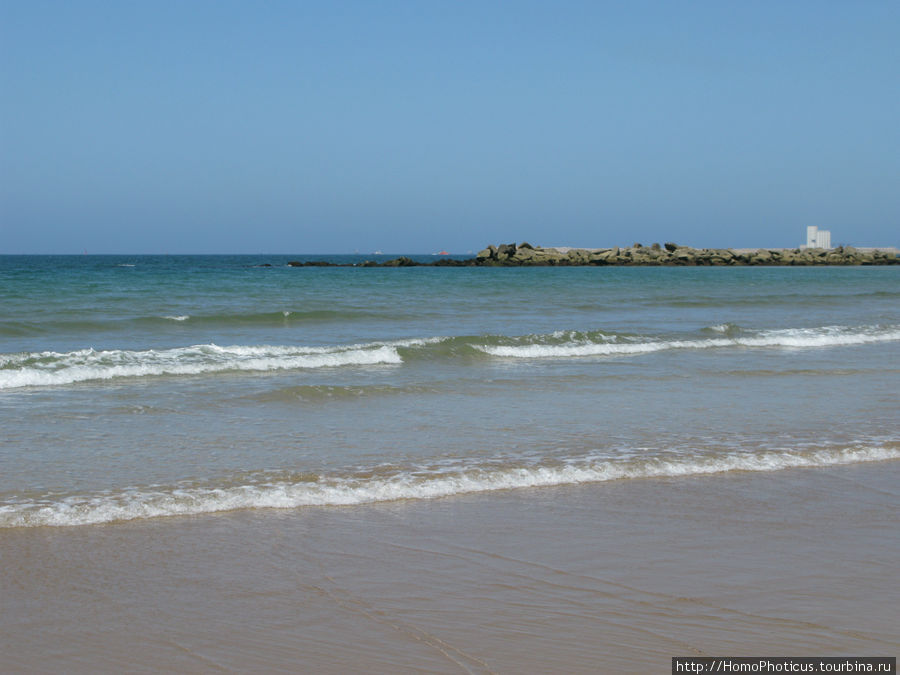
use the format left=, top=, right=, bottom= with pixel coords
left=288, top=242, right=900, bottom=267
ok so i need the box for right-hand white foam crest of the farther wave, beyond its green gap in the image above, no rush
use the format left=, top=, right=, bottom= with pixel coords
left=473, top=326, right=900, bottom=359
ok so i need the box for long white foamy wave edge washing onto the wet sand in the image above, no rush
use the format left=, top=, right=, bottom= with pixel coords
left=0, top=447, right=900, bottom=528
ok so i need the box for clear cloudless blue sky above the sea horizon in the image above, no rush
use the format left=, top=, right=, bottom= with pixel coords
left=0, top=0, right=900, bottom=254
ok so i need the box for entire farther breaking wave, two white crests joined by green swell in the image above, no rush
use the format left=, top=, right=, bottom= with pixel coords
left=0, top=324, right=900, bottom=390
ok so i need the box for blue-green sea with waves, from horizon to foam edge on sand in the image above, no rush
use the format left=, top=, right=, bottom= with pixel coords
left=0, top=256, right=900, bottom=527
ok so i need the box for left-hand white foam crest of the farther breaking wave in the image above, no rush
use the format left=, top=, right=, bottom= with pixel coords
left=0, top=343, right=406, bottom=390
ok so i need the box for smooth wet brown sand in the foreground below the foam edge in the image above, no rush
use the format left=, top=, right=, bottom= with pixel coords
left=0, top=461, right=900, bottom=673
